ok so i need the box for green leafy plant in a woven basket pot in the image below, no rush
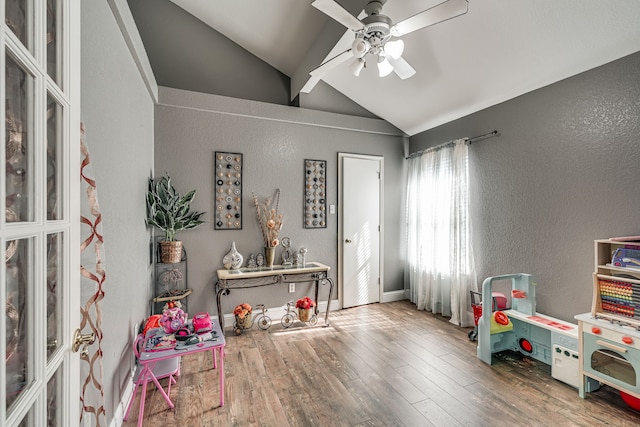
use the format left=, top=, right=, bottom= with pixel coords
left=146, top=175, right=204, bottom=264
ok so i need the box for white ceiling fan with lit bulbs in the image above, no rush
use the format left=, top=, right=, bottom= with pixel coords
left=309, top=0, right=469, bottom=80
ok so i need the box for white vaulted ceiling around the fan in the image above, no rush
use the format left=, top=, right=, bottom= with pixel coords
left=161, top=0, right=640, bottom=135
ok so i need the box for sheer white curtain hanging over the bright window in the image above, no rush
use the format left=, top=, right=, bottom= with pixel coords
left=407, top=139, right=478, bottom=326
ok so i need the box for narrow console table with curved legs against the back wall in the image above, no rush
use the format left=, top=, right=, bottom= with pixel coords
left=216, top=262, right=333, bottom=332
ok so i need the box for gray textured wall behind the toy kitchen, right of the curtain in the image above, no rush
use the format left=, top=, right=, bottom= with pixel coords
left=410, top=53, right=640, bottom=320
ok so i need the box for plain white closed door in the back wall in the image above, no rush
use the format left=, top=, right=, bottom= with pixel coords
left=339, top=154, right=382, bottom=308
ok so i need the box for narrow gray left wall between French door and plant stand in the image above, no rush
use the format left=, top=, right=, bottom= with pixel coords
left=81, top=1, right=153, bottom=419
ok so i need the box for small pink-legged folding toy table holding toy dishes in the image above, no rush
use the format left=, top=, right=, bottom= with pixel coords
left=131, top=319, right=225, bottom=427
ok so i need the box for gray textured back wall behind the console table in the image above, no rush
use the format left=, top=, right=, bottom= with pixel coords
left=155, top=88, right=405, bottom=313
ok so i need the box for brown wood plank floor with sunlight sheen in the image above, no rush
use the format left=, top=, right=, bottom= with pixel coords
left=123, top=301, right=640, bottom=427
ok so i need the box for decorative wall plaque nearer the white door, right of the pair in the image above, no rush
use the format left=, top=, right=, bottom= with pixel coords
left=303, top=159, right=327, bottom=228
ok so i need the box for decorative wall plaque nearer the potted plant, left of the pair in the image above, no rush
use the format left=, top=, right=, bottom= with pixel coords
left=214, top=151, right=242, bottom=230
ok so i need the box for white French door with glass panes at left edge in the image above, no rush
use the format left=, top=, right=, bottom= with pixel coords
left=0, top=0, right=80, bottom=426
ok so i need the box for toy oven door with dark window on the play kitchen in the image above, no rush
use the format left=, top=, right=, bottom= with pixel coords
left=583, top=333, right=640, bottom=393
